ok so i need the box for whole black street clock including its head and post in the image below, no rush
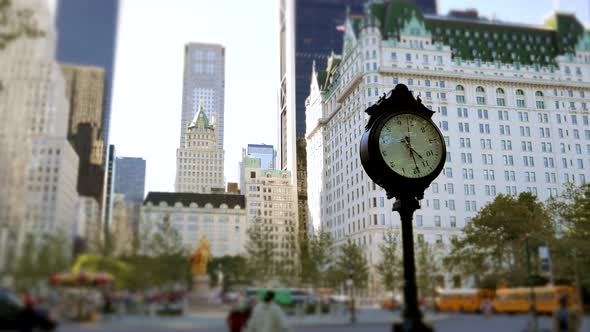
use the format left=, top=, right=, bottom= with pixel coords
left=360, top=84, right=446, bottom=332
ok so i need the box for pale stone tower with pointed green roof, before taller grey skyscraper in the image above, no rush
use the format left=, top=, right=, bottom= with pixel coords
left=175, top=104, right=224, bottom=193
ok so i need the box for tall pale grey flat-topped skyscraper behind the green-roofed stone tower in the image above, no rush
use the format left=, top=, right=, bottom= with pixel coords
left=180, top=43, right=225, bottom=150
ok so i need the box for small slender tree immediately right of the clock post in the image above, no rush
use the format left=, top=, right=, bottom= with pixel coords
left=415, top=240, right=441, bottom=298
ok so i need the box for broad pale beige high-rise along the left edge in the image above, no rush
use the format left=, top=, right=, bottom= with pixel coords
left=0, top=0, right=78, bottom=268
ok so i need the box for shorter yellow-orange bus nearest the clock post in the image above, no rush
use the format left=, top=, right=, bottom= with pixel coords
left=435, top=288, right=494, bottom=312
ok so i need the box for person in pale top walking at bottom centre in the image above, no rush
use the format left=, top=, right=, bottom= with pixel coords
left=247, top=291, right=290, bottom=332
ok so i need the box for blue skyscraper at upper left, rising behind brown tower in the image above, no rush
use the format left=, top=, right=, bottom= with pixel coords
left=57, top=0, right=119, bottom=144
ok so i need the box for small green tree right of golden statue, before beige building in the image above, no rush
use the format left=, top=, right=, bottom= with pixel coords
left=245, top=223, right=276, bottom=286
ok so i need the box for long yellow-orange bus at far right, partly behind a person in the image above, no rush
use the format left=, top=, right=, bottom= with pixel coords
left=492, top=286, right=578, bottom=314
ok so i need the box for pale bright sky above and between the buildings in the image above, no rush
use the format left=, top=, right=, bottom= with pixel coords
left=110, top=0, right=590, bottom=192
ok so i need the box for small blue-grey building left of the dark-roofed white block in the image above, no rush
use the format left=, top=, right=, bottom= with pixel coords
left=115, top=157, right=145, bottom=203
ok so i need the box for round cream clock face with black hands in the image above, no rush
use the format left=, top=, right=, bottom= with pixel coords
left=379, top=113, right=445, bottom=178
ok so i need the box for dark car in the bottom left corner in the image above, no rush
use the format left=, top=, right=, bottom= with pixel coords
left=0, top=290, right=57, bottom=331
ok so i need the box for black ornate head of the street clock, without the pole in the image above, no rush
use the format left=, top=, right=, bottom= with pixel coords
left=360, top=84, right=446, bottom=199
